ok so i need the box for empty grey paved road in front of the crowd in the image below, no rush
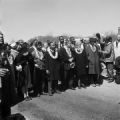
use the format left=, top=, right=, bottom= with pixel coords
left=12, top=81, right=120, bottom=120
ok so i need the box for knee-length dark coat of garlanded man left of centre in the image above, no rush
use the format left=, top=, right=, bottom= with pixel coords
left=45, top=52, right=60, bottom=80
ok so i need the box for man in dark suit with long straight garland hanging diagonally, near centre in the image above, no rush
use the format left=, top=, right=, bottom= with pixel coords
left=60, top=39, right=74, bottom=90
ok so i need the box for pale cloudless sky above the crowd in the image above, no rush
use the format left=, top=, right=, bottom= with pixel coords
left=0, top=0, right=120, bottom=41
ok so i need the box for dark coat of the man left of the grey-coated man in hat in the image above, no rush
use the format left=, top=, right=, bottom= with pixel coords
left=74, top=49, right=88, bottom=76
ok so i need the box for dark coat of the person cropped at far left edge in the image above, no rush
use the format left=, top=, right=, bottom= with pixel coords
left=0, top=50, right=17, bottom=107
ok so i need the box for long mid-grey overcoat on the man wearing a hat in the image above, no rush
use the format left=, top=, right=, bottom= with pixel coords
left=86, top=45, right=100, bottom=74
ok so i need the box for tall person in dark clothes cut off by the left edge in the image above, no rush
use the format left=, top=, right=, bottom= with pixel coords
left=0, top=33, right=15, bottom=119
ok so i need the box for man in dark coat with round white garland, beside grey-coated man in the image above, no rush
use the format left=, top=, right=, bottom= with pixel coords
left=74, top=41, right=88, bottom=88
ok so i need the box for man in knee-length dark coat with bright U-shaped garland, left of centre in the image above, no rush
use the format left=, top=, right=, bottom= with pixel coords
left=45, top=42, right=60, bottom=96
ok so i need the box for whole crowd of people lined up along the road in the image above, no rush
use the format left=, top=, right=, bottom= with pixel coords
left=0, top=33, right=119, bottom=118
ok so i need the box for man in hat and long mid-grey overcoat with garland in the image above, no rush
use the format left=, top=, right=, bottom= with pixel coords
left=86, top=38, right=100, bottom=87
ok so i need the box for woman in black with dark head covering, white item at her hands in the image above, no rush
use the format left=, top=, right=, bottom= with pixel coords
left=15, top=43, right=32, bottom=100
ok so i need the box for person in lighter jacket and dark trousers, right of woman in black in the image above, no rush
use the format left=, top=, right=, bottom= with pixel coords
left=31, top=41, right=46, bottom=97
